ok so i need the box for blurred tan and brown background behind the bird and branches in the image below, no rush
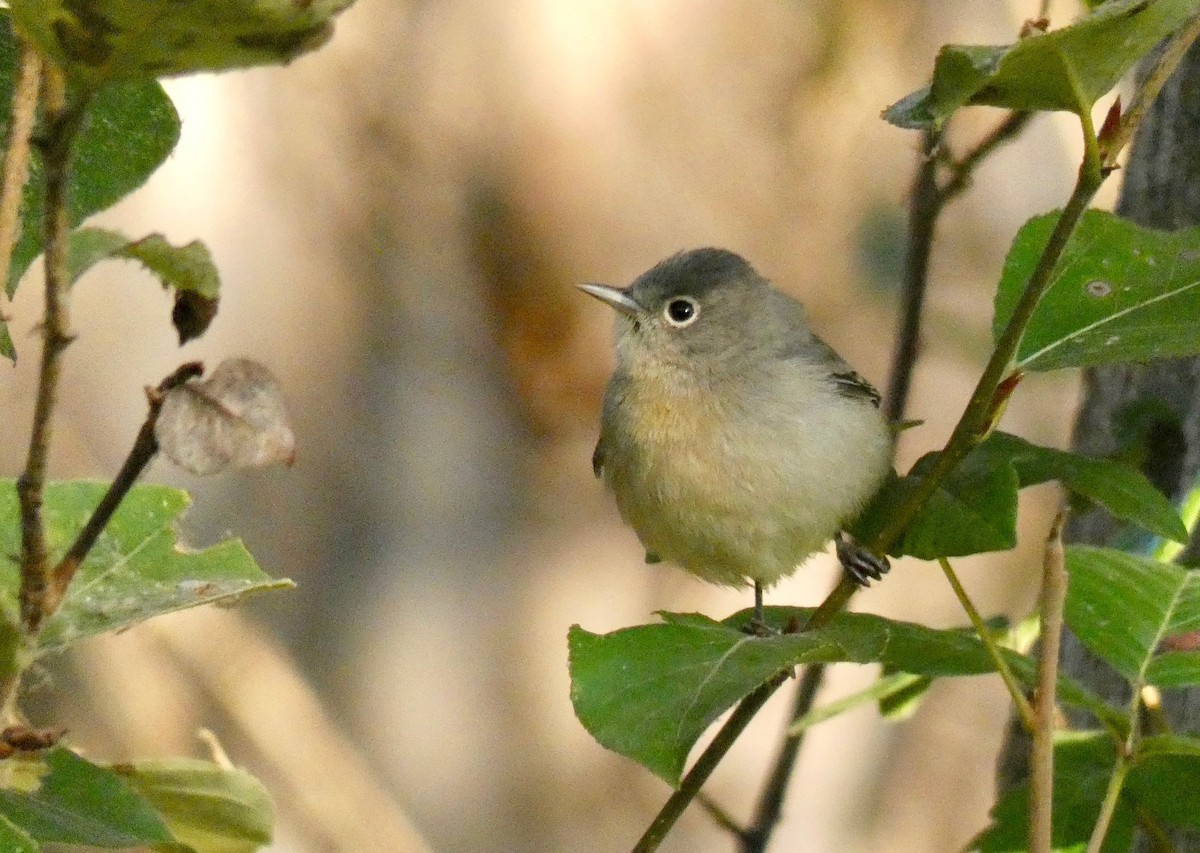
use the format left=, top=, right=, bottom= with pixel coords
left=0, top=0, right=1113, bottom=853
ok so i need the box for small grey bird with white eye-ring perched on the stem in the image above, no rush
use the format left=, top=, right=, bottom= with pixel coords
left=580, top=248, right=892, bottom=629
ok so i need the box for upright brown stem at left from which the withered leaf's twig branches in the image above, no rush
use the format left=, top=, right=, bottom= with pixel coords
left=17, top=66, right=77, bottom=635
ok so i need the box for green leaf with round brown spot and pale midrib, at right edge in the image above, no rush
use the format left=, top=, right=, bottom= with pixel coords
left=994, top=210, right=1200, bottom=371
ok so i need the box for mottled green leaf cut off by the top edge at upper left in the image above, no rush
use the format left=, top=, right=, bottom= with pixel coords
left=12, top=0, right=353, bottom=88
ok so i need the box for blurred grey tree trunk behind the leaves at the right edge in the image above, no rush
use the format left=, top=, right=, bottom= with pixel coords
left=1001, top=43, right=1200, bottom=853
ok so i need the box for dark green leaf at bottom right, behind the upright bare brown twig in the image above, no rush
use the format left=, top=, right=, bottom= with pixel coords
left=967, top=732, right=1134, bottom=853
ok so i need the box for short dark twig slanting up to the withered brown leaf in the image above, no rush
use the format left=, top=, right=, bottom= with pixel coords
left=42, top=361, right=204, bottom=617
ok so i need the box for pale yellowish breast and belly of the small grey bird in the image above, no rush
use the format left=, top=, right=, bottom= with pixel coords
left=605, top=391, right=887, bottom=585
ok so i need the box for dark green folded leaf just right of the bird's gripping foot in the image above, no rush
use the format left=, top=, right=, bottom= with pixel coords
left=851, top=431, right=1187, bottom=560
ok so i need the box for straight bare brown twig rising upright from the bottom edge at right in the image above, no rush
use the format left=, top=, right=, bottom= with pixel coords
left=1030, top=512, right=1067, bottom=853
